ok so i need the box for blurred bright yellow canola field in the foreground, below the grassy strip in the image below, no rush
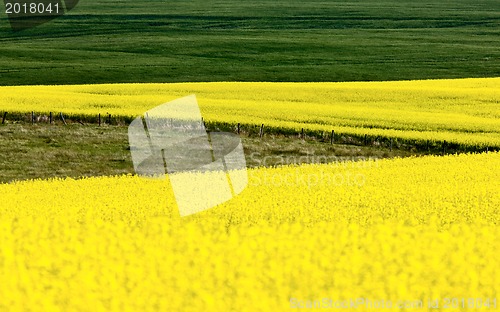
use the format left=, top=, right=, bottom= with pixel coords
left=0, top=152, right=500, bottom=311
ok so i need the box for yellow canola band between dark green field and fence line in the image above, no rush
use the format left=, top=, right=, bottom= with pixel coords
left=0, top=78, right=500, bottom=146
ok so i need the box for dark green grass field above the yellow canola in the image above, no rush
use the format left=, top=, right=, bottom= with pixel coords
left=0, top=0, right=500, bottom=85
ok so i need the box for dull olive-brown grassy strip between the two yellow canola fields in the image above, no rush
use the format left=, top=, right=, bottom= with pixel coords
left=0, top=119, right=434, bottom=183
